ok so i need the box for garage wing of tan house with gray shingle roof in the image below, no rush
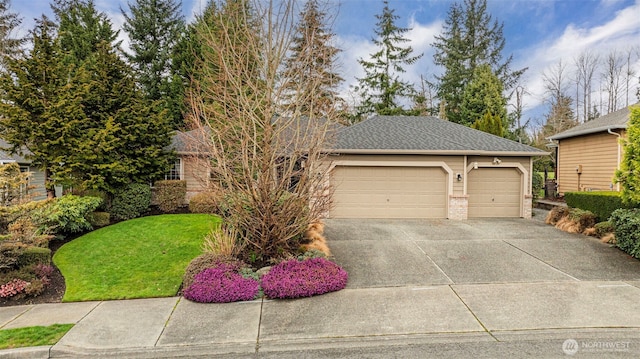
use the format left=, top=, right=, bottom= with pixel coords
left=328, top=116, right=548, bottom=220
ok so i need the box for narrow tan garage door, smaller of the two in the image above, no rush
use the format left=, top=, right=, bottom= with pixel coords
left=467, top=168, right=522, bottom=218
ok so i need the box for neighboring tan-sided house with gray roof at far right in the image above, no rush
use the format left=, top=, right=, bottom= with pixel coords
left=549, top=108, right=630, bottom=195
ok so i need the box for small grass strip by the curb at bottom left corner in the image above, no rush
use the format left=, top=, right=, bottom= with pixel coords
left=0, top=324, right=73, bottom=349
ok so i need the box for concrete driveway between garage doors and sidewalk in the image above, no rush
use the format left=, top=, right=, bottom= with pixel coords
left=325, top=219, right=640, bottom=288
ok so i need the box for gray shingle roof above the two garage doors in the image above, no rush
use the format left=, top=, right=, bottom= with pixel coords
left=331, top=116, right=548, bottom=156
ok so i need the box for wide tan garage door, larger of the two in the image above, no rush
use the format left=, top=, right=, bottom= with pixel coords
left=330, top=166, right=447, bottom=218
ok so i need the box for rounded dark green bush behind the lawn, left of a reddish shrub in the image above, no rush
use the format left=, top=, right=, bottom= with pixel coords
left=110, top=183, right=151, bottom=221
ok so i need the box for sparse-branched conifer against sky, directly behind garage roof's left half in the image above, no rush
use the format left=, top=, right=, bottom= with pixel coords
left=356, top=0, right=422, bottom=118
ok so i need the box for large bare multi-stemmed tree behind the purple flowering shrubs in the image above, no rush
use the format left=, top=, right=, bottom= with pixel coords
left=190, top=0, right=337, bottom=265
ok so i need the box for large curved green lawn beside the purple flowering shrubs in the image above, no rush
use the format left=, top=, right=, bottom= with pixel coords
left=53, top=214, right=220, bottom=302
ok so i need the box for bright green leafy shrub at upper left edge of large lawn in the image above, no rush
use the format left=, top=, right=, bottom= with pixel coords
left=37, top=194, right=102, bottom=233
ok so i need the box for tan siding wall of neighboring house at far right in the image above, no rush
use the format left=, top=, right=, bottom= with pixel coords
left=558, top=132, right=619, bottom=193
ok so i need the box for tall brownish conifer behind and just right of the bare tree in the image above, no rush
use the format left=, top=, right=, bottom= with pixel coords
left=283, top=0, right=344, bottom=117
